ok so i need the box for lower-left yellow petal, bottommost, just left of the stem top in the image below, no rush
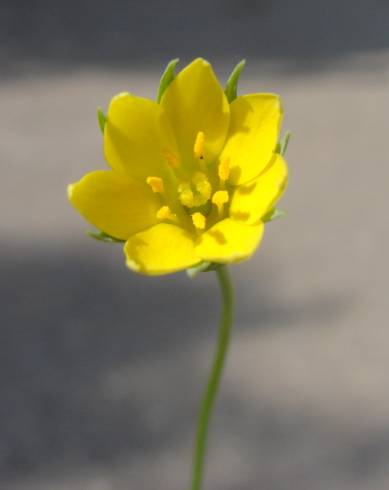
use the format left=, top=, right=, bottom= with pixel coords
left=124, top=223, right=200, bottom=276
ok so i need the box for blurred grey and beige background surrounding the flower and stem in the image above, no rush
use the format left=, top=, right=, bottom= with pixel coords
left=0, top=0, right=389, bottom=490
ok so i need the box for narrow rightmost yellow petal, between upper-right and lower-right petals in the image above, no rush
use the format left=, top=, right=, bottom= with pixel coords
left=230, top=155, right=288, bottom=224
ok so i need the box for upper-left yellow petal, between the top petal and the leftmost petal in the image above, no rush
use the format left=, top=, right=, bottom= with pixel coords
left=104, top=93, right=178, bottom=181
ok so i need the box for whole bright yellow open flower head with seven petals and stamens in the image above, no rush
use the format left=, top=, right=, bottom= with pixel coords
left=69, top=58, right=287, bottom=275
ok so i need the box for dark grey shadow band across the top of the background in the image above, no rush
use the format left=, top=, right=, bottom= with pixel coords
left=0, top=0, right=389, bottom=76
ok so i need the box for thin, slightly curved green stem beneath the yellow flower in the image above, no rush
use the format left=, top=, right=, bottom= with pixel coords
left=191, top=266, right=233, bottom=490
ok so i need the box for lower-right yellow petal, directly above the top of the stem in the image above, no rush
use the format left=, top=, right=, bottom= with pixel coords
left=196, top=218, right=264, bottom=263
